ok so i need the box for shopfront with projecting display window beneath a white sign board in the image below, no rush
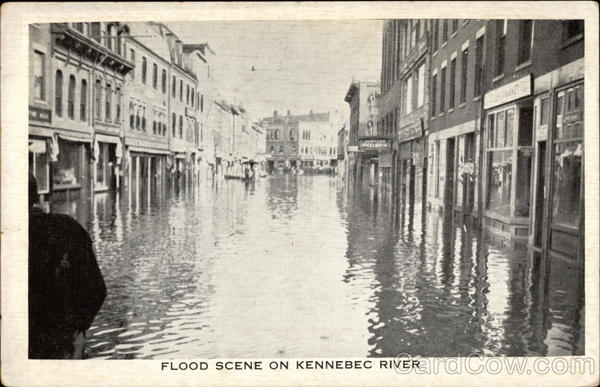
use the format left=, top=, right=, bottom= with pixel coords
left=482, top=75, right=533, bottom=240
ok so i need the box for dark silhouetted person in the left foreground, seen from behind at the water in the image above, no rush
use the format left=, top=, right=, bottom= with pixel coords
left=29, top=174, right=106, bottom=359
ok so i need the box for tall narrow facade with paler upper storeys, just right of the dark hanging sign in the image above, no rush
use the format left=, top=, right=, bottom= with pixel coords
left=378, top=19, right=431, bottom=209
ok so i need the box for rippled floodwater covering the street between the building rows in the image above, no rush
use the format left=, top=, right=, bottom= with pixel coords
left=58, top=175, right=584, bottom=359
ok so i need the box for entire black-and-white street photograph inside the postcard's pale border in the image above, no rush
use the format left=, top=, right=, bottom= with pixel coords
left=28, top=19, right=586, bottom=359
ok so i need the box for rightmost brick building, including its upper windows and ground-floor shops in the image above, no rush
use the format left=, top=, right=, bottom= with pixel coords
left=482, top=20, right=584, bottom=265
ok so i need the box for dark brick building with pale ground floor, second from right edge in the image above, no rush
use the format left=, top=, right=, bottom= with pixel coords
left=427, top=19, right=486, bottom=221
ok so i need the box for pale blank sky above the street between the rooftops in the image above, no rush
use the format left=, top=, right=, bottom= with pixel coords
left=165, top=20, right=383, bottom=120
